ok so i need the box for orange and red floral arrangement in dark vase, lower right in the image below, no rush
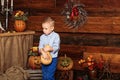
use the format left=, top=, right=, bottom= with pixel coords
left=78, top=55, right=104, bottom=80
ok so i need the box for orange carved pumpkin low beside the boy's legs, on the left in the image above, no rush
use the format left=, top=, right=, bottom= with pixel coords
left=28, top=56, right=41, bottom=69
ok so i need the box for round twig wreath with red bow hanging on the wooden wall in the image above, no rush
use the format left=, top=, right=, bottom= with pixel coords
left=62, top=0, right=87, bottom=28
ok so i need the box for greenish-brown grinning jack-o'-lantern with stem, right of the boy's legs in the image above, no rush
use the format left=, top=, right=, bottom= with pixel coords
left=57, top=55, right=73, bottom=70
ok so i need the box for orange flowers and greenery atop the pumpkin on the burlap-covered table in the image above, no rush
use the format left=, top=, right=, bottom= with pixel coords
left=14, top=10, right=28, bottom=21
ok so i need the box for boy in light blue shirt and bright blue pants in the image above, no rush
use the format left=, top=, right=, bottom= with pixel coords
left=39, top=17, right=60, bottom=80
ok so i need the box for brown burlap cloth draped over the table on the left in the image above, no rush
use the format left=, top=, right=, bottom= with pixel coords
left=0, top=31, right=34, bottom=72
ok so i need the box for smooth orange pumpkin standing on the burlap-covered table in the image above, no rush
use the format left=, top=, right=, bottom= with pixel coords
left=14, top=20, right=26, bottom=32
